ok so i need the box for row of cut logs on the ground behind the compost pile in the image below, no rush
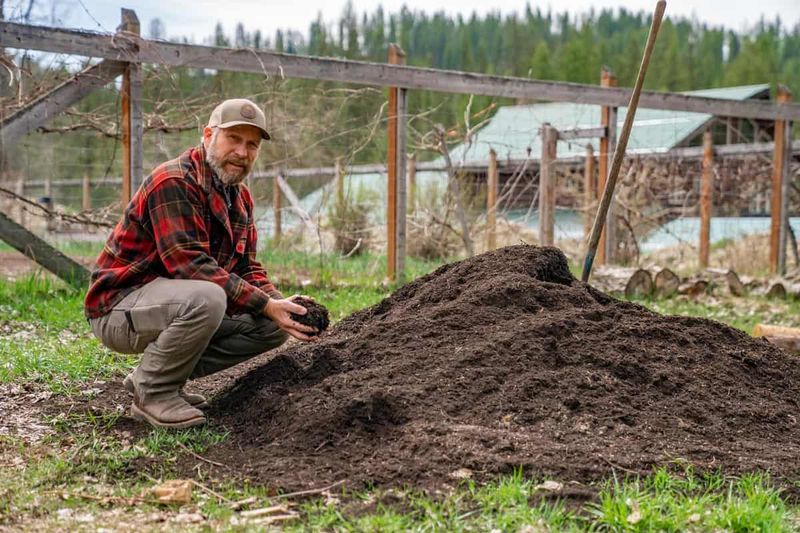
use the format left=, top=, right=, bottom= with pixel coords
left=592, top=265, right=800, bottom=299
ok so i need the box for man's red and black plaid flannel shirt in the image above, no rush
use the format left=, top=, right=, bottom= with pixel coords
left=84, top=145, right=280, bottom=318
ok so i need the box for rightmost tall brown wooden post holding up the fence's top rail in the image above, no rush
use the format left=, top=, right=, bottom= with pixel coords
left=769, top=85, right=792, bottom=274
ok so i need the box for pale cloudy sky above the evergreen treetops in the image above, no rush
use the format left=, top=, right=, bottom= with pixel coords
left=5, top=0, right=800, bottom=43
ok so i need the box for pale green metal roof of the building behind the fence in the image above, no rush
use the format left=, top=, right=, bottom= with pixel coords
left=450, top=84, right=769, bottom=164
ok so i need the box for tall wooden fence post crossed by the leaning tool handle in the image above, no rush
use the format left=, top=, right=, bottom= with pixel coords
left=596, top=67, right=617, bottom=265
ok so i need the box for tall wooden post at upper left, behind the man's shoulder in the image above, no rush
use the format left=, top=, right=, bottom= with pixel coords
left=120, top=8, right=144, bottom=207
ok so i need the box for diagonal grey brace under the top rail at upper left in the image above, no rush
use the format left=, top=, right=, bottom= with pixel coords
left=0, top=60, right=125, bottom=151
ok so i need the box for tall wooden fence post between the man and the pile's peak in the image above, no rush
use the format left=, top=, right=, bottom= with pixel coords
left=386, top=44, right=405, bottom=281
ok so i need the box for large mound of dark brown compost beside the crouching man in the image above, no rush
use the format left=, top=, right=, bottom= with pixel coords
left=208, top=245, right=800, bottom=488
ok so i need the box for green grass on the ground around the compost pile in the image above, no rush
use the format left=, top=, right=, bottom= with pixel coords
left=0, top=252, right=800, bottom=532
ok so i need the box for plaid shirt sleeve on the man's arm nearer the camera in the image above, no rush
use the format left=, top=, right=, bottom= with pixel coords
left=147, top=178, right=274, bottom=314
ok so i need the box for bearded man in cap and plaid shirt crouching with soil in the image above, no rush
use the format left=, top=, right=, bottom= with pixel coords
left=85, top=99, right=315, bottom=428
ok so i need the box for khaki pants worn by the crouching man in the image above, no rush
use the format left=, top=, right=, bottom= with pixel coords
left=89, top=278, right=287, bottom=401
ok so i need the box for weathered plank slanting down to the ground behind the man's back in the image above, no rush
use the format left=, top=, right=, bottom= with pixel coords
left=0, top=212, right=89, bottom=286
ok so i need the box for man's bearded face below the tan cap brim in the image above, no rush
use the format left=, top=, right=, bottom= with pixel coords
left=203, top=124, right=261, bottom=185
